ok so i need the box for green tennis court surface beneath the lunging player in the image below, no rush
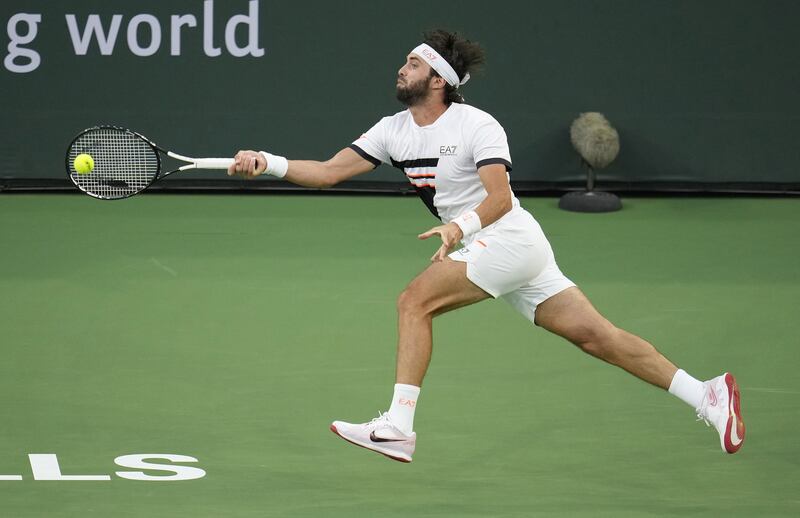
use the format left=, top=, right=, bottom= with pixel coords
left=0, top=194, right=800, bottom=518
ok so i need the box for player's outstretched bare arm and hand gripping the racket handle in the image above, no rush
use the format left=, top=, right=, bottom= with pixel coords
left=228, top=148, right=375, bottom=189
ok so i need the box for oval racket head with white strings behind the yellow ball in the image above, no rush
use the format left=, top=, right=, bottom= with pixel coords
left=68, top=128, right=160, bottom=199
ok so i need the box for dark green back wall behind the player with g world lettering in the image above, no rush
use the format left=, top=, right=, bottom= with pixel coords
left=0, top=0, right=800, bottom=188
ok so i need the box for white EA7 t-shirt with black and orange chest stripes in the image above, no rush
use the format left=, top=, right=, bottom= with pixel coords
left=350, top=103, right=519, bottom=223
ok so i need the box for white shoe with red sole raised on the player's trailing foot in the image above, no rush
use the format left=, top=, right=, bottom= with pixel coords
left=697, top=372, right=744, bottom=453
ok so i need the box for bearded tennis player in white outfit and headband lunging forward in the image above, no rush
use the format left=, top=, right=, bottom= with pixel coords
left=228, top=30, right=745, bottom=462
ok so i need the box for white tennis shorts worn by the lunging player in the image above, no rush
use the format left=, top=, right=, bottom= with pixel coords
left=449, top=207, right=575, bottom=322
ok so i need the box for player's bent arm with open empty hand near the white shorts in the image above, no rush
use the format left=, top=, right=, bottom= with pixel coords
left=418, top=164, right=512, bottom=262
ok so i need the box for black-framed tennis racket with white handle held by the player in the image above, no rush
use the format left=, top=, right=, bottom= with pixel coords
left=66, top=126, right=233, bottom=200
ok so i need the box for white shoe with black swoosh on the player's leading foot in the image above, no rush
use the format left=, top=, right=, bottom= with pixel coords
left=331, top=413, right=417, bottom=462
